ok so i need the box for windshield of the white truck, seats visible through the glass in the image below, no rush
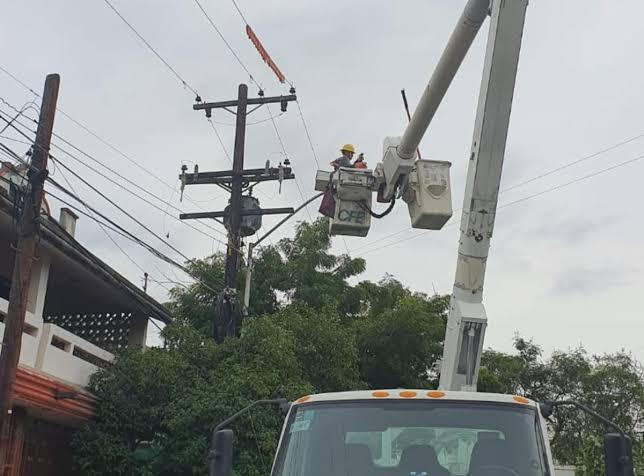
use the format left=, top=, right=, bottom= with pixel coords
left=272, top=400, right=548, bottom=476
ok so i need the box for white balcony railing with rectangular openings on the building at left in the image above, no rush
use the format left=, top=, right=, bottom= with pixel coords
left=0, top=298, right=114, bottom=386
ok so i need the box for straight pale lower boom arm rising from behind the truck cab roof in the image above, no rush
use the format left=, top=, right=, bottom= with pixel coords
left=440, top=0, right=528, bottom=391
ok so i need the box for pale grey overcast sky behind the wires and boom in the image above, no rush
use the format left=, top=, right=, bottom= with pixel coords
left=0, top=0, right=644, bottom=359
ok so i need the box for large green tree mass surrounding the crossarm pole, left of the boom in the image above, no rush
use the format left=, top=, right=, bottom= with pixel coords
left=75, top=220, right=447, bottom=476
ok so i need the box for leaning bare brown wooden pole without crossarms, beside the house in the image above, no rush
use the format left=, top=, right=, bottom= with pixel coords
left=0, top=74, right=60, bottom=462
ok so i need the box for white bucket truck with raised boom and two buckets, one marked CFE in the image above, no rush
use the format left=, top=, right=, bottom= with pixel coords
left=210, top=0, right=633, bottom=476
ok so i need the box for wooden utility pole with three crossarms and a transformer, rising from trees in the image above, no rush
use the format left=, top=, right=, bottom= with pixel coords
left=179, top=84, right=297, bottom=342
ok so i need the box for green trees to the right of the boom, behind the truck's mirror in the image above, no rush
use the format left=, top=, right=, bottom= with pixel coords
left=479, top=337, right=644, bottom=476
